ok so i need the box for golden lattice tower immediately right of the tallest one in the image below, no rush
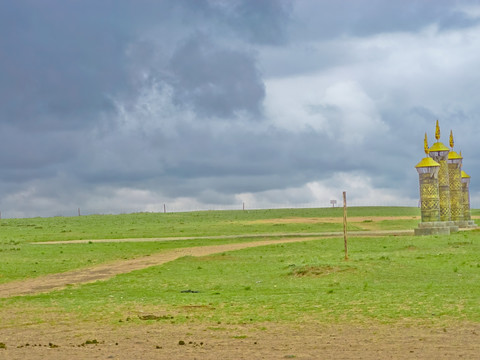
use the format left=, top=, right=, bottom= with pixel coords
left=447, top=131, right=465, bottom=227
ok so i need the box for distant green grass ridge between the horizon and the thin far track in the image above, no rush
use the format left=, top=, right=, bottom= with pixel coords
left=0, top=207, right=420, bottom=242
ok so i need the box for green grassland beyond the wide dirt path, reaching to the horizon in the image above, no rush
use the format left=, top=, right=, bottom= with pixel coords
left=0, top=207, right=418, bottom=284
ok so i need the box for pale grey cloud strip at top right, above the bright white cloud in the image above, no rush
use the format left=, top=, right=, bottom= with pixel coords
left=293, top=0, right=479, bottom=40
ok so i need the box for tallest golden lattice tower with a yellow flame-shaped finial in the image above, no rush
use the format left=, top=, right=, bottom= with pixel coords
left=430, top=120, right=452, bottom=221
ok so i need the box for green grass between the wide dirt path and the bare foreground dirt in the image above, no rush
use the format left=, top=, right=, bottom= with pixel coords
left=2, top=233, right=480, bottom=323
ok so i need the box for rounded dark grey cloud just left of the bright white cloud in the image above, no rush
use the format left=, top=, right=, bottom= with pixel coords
left=170, top=35, right=265, bottom=117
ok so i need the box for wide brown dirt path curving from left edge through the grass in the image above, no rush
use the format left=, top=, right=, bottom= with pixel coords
left=0, top=237, right=317, bottom=298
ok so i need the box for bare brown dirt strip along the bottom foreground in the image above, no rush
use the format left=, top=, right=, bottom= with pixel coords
left=0, top=322, right=480, bottom=360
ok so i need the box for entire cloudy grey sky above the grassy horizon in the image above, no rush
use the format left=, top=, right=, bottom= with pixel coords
left=0, top=0, right=480, bottom=217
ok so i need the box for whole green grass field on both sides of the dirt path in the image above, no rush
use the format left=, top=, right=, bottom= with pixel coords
left=0, top=208, right=480, bottom=326
